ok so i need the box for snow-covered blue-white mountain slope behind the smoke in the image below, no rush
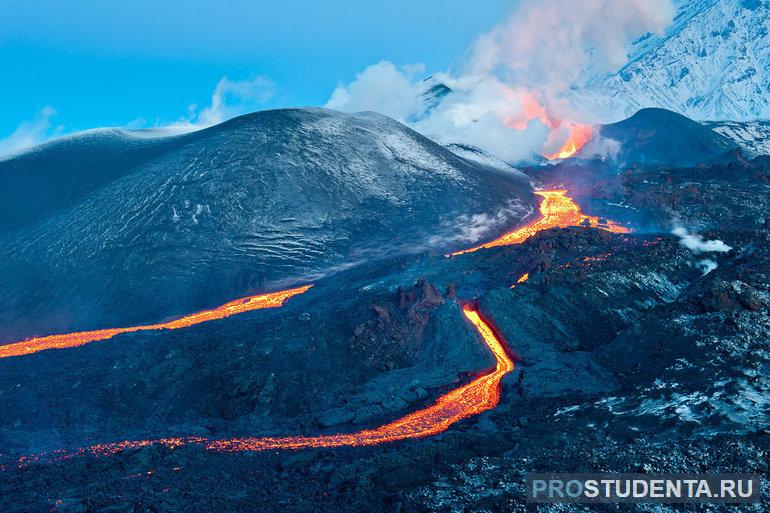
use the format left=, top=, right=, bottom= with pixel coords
left=570, top=0, right=770, bottom=122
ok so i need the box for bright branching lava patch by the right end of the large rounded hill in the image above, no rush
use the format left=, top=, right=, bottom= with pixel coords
left=450, top=190, right=630, bottom=256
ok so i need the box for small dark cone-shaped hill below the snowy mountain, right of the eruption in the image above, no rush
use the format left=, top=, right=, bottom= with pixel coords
left=599, top=109, right=738, bottom=166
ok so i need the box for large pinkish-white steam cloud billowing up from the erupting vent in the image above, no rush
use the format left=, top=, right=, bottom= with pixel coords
left=326, top=0, right=674, bottom=161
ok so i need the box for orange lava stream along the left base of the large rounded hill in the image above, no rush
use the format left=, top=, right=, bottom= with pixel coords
left=0, top=285, right=312, bottom=358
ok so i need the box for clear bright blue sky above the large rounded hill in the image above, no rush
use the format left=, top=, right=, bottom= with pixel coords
left=0, top=0, right=512, bottom=139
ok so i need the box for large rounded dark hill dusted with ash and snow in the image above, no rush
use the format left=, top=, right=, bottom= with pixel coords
left=0, top=109, right=531, bottom=341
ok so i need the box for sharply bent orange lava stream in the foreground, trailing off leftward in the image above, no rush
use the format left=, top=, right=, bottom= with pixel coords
left=12, top=305, right=515, bottom=466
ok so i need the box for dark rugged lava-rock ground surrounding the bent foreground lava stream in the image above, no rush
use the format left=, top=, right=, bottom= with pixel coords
left=0, top=107, right=770, bottom=513
